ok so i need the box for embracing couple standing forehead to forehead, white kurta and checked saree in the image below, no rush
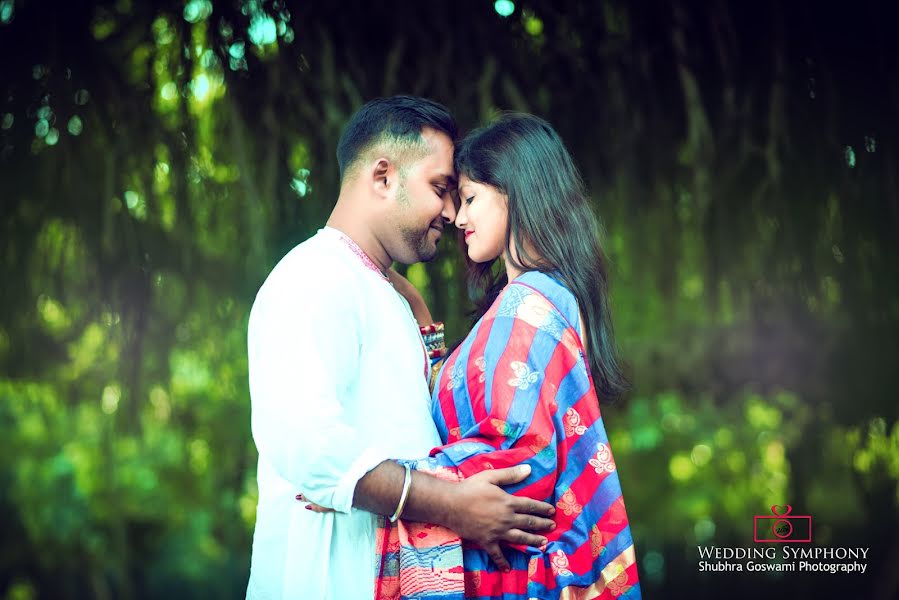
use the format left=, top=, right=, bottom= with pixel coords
left=247, top=96, right=640, bottom=600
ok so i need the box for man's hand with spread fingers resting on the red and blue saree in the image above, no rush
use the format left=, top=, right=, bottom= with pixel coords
left=446, top=465, right=556, bottom=571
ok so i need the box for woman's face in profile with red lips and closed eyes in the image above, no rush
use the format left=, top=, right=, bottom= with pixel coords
left=456, top=175, right=509, bottom=263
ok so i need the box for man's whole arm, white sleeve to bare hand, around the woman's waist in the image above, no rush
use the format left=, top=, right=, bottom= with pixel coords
left=249, top=270, right=553, bottom=567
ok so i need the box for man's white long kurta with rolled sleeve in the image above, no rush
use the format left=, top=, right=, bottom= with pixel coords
left=247, top=228, right=440, bottom=600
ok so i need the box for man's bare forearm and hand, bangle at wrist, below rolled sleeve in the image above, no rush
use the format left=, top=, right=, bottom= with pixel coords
left=353, top=461, right=555, bottom=570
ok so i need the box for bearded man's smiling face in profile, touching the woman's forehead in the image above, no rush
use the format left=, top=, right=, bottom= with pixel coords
left=388, top=128, right=456, bottom=264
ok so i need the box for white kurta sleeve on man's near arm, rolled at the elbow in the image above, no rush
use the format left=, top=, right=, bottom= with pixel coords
left=248, top=278, right=389, bottom=513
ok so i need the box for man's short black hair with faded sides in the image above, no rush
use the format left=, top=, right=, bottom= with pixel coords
left=337, top=96, right=457, bottom=183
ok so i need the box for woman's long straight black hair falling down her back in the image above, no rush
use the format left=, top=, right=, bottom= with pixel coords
left=454, top=113, right=628, bottom=400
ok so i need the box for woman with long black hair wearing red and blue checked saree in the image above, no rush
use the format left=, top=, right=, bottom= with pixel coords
left=376, top=114, right=640, bottom=599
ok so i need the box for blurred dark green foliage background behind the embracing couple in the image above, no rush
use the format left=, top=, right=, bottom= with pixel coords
left=0, top=0, right=899, bottom=600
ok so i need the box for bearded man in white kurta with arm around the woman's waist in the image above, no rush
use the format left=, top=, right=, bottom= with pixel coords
left=247, top=96, right=553, bottom=600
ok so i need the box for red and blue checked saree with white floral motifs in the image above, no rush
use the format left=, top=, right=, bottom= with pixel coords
left=375, top=272, right=640, bottom=600
